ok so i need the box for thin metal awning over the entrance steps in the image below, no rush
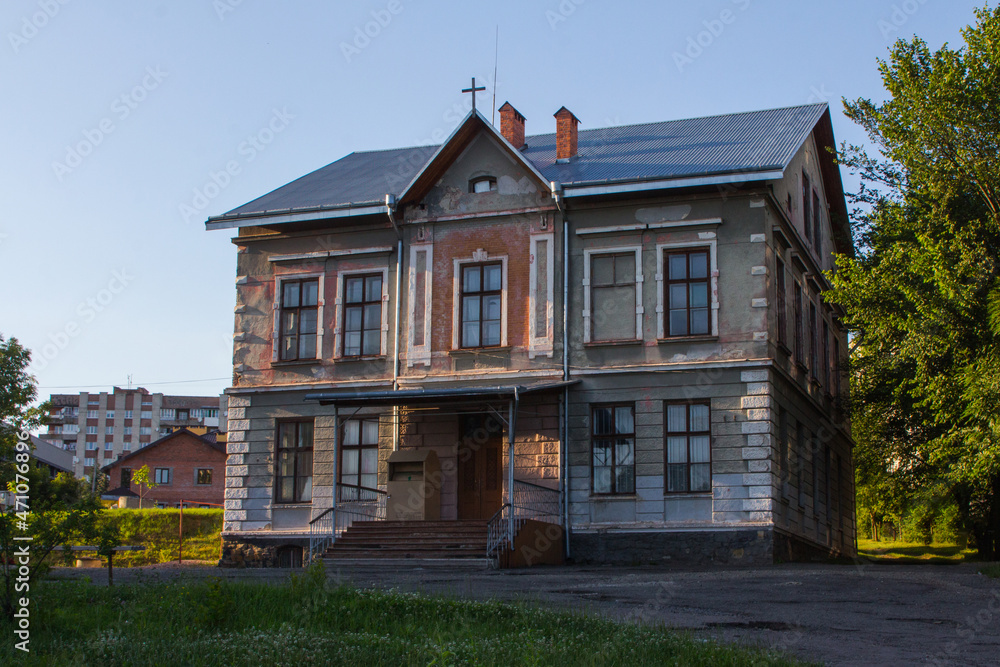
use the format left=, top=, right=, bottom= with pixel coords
left=305, top=380, right=580, bottom=407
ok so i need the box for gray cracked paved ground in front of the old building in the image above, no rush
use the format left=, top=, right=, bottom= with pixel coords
left=55, top=561, right=1000, bottom=665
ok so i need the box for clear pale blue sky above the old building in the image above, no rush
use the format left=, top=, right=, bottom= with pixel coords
left=0, top=0, right=978, bottom=396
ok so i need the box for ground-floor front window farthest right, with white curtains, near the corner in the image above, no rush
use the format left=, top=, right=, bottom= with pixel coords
left=666, top=403, right=712, bottom=493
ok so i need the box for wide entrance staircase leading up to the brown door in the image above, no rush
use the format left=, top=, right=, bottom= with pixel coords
left=323, top=521, right=486, bottom=560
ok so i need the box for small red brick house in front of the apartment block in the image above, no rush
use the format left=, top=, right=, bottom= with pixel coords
left=101, top=429, right=226, bottom=507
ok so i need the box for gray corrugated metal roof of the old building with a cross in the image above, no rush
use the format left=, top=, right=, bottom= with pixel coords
left=212, top=104, right=827, bottom=220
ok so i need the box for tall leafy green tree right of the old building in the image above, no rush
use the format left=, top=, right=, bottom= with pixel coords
left=828, top=8, right=1000, bottom=559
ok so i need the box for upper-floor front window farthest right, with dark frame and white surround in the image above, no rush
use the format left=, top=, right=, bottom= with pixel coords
left=664, top=248, right=709, bottom=336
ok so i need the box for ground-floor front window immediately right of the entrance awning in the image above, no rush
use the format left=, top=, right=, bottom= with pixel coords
left=591, top=405, right=635, bottom=494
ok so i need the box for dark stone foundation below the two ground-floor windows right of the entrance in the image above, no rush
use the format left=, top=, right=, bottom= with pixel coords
left=570, top=528, right=774, bottom=566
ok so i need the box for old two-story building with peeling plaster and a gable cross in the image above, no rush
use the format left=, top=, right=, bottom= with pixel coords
left=207, top=98, right=855, bottom=564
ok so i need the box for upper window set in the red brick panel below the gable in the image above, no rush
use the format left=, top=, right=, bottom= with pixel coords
left=460, top=262, right=503, bottom=347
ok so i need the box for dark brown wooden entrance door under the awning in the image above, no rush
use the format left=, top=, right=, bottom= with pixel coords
left=458, top=415, right=503, bottom=521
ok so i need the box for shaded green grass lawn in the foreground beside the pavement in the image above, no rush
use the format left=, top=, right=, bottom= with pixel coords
left=0, top=570, right=802, bottom=667
